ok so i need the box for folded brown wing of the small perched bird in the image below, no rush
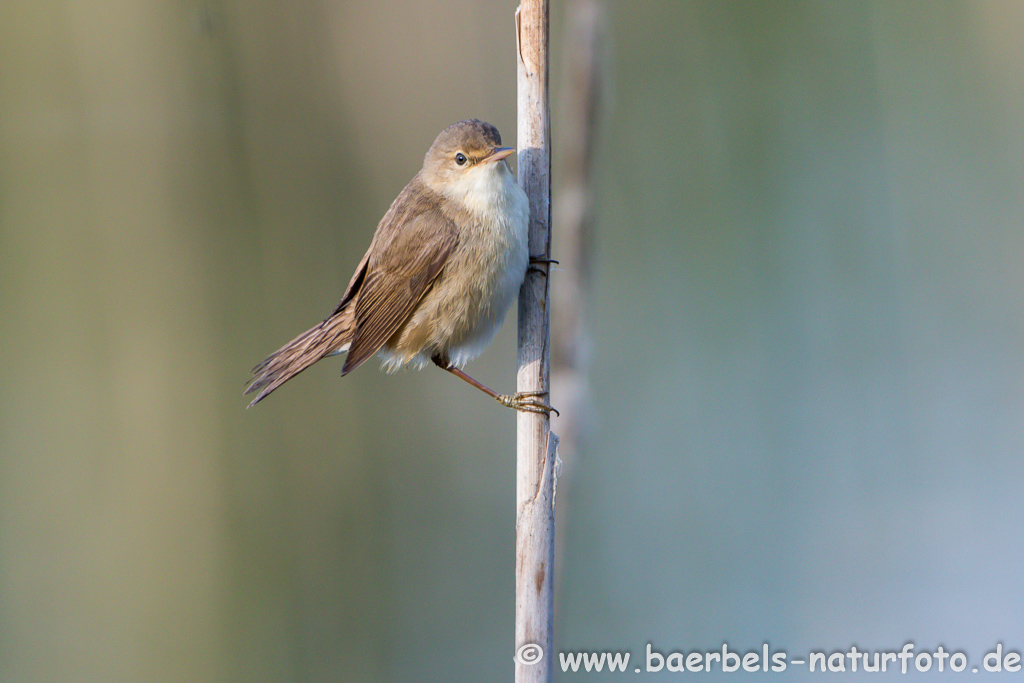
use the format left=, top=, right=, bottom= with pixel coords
left=341, top=198, right=459, bottom=375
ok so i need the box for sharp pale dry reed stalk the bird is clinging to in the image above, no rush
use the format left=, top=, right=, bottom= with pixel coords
left=515, top=0, right=558, bottom=683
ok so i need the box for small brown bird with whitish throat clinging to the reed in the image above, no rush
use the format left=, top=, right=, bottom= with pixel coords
left=246, top=119, right=553, bottom=414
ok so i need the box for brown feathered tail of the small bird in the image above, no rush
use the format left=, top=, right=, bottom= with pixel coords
left=245, top=307, right=353, bottom=408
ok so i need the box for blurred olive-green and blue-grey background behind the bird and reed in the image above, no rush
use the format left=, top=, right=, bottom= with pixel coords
left=0, top=0, right=1024, bottom=681
